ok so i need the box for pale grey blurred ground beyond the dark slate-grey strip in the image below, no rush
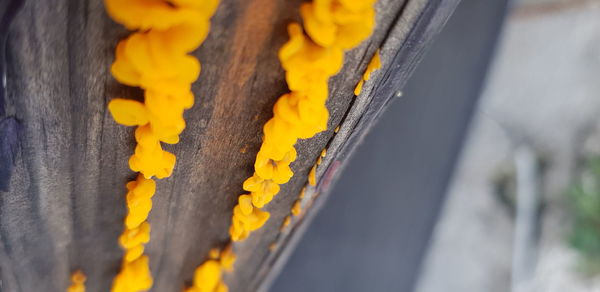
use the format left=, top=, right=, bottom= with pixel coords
left=416, top=0, right=600, bottom=292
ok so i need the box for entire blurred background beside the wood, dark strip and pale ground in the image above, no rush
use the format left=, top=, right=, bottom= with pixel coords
left=271, top=0, right=600, bottom=292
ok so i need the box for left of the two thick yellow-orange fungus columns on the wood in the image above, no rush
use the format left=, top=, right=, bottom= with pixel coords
left=104, top=0, right=218, bottom=292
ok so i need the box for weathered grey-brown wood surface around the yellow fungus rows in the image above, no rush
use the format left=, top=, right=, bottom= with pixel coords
left=0, top=0, right=458, bottom=292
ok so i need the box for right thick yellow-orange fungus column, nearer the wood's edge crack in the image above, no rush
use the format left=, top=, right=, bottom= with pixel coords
left=194, top=0, right=375, bottom=291
